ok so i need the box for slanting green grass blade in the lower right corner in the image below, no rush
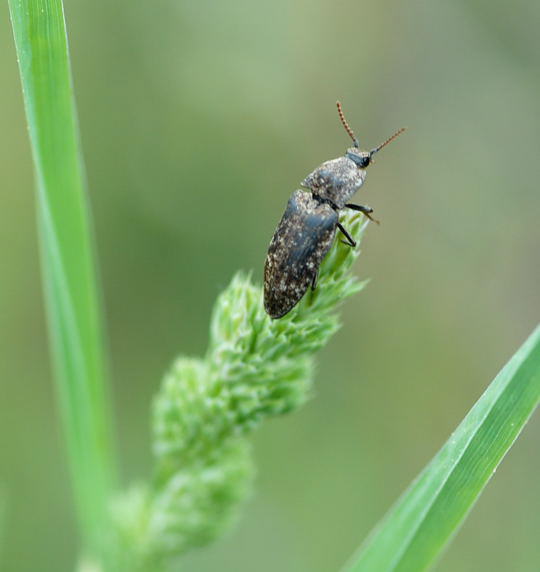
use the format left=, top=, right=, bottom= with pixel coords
left=345, top=327, right=540, bottom=572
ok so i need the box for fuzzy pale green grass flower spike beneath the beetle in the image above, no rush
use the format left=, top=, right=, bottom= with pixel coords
left=113, top=214, right=365, bottom=571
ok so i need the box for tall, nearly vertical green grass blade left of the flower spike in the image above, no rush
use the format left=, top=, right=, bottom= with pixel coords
left=9, top=0, right=114, bottom=558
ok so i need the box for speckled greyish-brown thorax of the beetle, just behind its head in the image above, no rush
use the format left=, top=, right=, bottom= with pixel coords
left=302, top=155, right=366, bottom=209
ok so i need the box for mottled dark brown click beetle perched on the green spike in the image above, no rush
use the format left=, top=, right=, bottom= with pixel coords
left=264, top=101, right=405, bottom=319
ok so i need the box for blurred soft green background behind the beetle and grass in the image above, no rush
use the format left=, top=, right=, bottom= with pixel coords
left=0, top=0, right=540, bottom=572
